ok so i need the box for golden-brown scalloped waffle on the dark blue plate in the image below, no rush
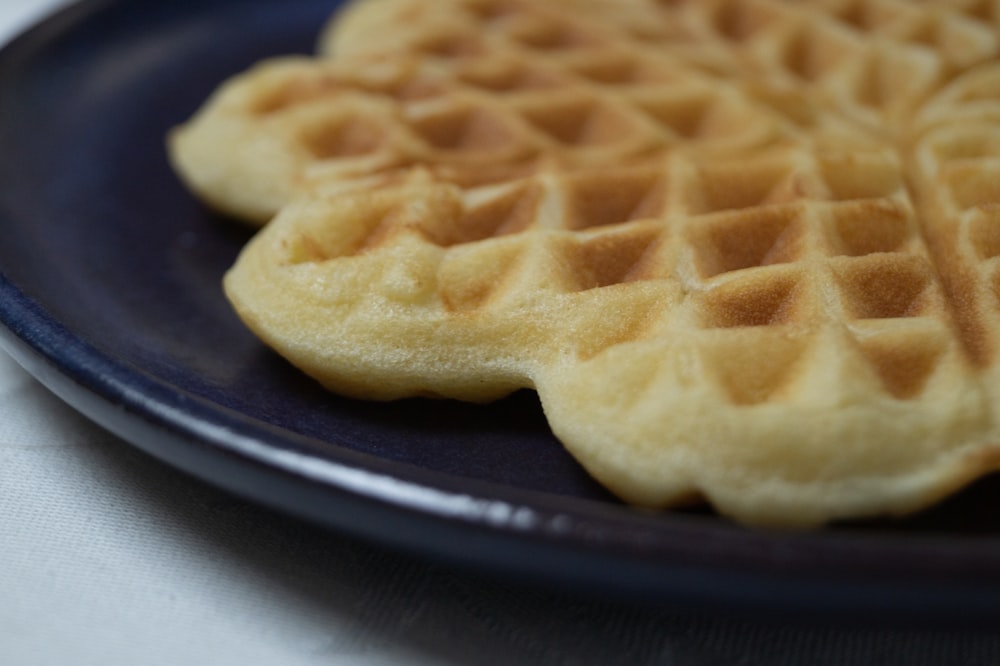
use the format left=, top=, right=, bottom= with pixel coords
left=178, top=0, right=1000, bottom=527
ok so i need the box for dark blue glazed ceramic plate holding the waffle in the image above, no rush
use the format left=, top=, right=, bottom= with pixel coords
left=0, top=0, right=1000, bottom=617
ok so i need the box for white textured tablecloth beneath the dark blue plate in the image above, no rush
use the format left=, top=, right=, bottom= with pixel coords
left=0, top=0, right=1000, bottom=666
